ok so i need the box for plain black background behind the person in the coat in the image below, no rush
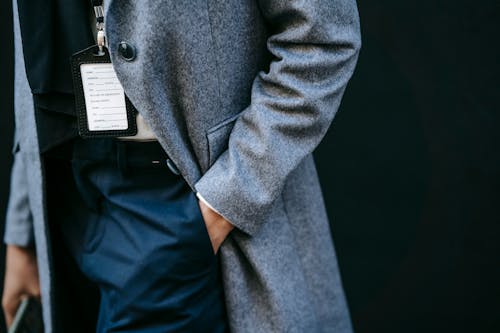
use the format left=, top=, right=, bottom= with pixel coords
left=0, top=0, right=500, bottom=333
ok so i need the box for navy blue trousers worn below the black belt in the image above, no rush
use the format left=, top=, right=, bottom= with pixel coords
left=49, top=139, right=228, bottom=333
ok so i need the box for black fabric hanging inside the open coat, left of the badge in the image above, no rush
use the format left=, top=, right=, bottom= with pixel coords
left=18, top=0, right=94, bottom=152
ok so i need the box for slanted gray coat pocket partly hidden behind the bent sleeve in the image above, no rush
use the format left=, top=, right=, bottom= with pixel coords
left=207, top=113, right=241, bottom=167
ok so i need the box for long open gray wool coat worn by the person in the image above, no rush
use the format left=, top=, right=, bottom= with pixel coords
left=5, top=0, right=361, bottom=333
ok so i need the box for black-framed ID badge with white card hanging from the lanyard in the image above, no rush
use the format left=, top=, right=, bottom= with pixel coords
left=71, top=45, right=137, bottom=139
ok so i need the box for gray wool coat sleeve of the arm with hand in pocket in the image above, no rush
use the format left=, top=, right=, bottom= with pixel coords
left=195, top=0, right=361, bottom=235
